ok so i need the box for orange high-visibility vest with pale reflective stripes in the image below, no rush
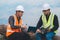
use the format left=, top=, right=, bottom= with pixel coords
left=6, top=15, right=23, bottom=37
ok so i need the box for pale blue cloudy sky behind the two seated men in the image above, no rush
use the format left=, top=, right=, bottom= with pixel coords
left=0, top=0, right=60, bottom=35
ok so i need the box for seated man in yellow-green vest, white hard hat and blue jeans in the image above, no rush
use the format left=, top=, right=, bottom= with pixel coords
left=36, top=4, right=59, bottom=40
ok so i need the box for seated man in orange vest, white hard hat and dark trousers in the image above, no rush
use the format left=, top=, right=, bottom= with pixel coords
left=6, top=5, right=29, bottom=40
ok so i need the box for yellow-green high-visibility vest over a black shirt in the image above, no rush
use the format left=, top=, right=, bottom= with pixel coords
left=42, top=13, right=56, bottom=33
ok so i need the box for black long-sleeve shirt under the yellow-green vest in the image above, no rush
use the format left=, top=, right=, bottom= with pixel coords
left=37, top=15, right=59, bottom=31
